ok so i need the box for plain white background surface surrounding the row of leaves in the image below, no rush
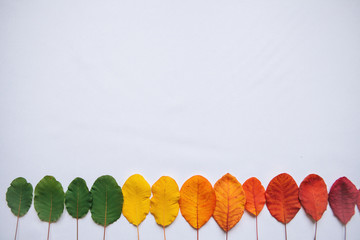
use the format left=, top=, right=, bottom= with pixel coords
left=0, top=0, right=360, bottom=240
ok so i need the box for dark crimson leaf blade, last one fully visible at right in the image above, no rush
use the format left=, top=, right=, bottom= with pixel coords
left=329, top=177, right=359, bottom=225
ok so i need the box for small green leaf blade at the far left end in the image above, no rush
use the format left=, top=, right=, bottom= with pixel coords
left=6, top=177, right=33, bottom=217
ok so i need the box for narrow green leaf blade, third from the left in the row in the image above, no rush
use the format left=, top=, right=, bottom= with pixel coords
left=65, top=178, right=92, bottom=219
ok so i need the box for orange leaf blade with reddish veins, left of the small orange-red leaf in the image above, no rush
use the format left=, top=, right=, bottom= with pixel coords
left=213, top=173, right=246, bottom=232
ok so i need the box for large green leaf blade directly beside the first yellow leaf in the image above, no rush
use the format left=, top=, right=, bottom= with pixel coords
left=90, top=175, right=123, bottom=227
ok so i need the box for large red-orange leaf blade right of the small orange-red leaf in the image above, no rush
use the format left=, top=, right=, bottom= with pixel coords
left=265, top=173, right=301, bottom=224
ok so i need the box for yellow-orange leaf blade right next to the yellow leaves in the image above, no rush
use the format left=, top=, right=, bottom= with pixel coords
left=179, top=175, right=216, bottom=229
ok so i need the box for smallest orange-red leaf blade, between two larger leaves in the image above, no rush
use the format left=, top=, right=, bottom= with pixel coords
left=243, top=177, right=266, bottom=216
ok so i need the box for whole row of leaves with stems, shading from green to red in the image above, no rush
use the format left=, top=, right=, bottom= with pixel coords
left=6, top=173, right=360, bottom=239
